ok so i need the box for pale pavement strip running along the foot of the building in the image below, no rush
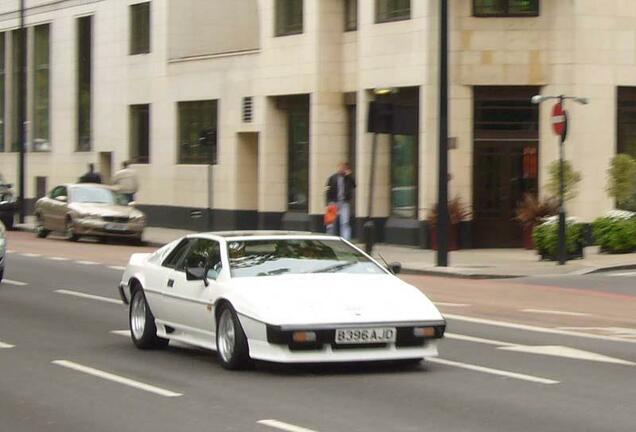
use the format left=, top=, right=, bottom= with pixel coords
left=16, top=223, right=636, bottom=279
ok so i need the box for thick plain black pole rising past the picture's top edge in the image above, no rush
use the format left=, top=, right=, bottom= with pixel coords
left=436, top=0, right=449, bottom=267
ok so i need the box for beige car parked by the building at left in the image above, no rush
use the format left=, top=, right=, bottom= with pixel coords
left=35, top=183, right=146, bottom=243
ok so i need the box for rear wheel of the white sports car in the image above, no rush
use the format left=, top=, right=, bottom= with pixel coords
left=128, top=289, right=169, bottom=350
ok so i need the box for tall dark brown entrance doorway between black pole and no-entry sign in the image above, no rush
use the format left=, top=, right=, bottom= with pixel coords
left=473, top=87, right=539, bottom=248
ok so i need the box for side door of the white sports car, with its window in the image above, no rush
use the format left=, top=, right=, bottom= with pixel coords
left=164, top=238, right=222, bottom=338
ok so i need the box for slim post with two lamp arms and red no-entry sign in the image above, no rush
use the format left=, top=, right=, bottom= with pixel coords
left=532, top=95, right=589, bottom=265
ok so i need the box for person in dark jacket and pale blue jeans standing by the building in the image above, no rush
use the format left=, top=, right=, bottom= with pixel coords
left=326, top=162, right=356, bottom=240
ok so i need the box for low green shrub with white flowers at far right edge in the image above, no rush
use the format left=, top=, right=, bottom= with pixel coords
left=592, top=217, right=636, bottom=253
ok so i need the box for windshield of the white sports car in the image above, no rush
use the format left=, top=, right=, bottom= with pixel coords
left=227, top=239, right=385, bottom=277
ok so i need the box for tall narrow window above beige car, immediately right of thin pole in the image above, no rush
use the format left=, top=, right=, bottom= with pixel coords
left=33, top=24, right=51, bottom=151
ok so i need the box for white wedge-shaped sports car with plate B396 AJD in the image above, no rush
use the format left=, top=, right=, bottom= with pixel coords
left=119, top=232, right=446, bottom=369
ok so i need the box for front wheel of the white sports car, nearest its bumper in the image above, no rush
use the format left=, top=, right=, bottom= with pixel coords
left=216, top=304, right=250, bottom=370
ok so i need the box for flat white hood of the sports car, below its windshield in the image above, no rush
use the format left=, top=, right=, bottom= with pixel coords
left=230, top=274, right=443, bottom=325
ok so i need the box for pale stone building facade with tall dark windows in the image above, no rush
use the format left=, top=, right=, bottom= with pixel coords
left=0, top=0, right=636, bottom=247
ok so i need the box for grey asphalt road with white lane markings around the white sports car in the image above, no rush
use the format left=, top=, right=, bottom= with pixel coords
left=0, top=239, right=636, bottom=432
